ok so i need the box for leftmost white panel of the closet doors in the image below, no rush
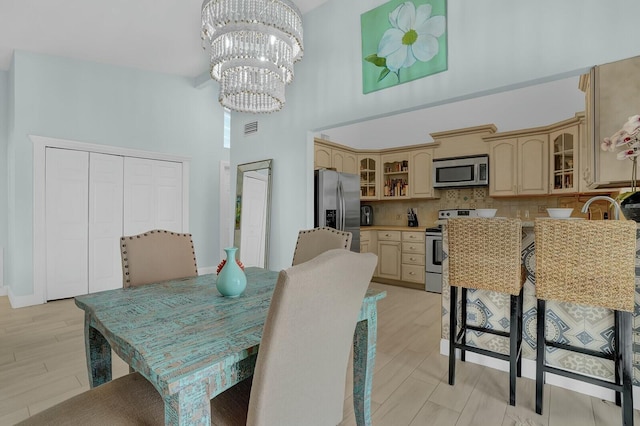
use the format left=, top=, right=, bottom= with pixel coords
left=45, top=148, right=89, bottom=300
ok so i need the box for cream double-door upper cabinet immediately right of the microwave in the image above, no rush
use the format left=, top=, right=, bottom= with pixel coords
left=485, top=133, right=549, bottom=197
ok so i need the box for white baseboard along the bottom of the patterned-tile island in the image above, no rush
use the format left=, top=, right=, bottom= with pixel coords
left=440, top=339, right=640, bottom=408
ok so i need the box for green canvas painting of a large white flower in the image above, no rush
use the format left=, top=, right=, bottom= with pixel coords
left=360, top=0, right=447, bottom=93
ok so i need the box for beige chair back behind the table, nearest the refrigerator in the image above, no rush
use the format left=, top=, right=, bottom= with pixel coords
left=292, top=226, right=352, bottom=266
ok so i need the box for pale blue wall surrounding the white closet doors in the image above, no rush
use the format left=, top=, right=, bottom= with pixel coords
left=7, top=52, right=229, bottom=296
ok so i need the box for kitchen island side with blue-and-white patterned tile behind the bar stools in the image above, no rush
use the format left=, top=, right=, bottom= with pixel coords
left=440, top=222, right=640, bottom=399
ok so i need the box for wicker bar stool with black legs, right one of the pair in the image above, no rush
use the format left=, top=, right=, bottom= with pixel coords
left=535, top=219, right=636, bottom=426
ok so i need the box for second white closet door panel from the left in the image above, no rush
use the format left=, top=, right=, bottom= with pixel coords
left=89, top=152, right=124, bottom=293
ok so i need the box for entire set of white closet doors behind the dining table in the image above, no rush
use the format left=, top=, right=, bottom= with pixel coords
left=37, top=136, right=189, bottom=302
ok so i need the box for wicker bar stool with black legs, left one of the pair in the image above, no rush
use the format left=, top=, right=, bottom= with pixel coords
left=447, top=218, right=525, bottom=405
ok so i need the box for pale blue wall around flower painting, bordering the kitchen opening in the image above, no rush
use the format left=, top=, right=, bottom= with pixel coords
left=231, top=0, right=640, bottom=268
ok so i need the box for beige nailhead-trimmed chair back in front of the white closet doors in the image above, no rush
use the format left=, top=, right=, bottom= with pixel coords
left=120, top=229, right=198, bottom=287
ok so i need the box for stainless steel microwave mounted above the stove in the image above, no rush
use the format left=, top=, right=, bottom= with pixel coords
left=433, top=155, right=489, bottom=188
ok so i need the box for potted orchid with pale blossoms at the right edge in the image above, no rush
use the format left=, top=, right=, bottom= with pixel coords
left=600, top=115, right=640, bottom=222
